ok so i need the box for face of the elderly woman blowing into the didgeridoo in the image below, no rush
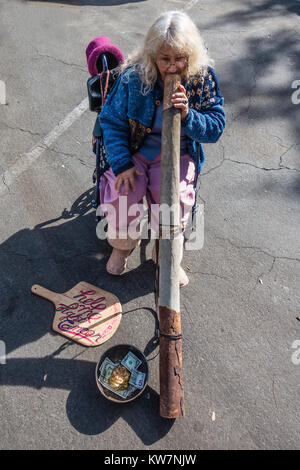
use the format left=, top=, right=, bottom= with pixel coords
left=156, top=45, right=188, bottom=81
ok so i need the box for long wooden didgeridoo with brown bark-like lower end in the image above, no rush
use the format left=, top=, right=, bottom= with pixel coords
left=158, top=74, right=185, bottom=419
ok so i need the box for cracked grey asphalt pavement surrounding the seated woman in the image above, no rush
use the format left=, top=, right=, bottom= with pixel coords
left=0, top=0, right=300, bottom=451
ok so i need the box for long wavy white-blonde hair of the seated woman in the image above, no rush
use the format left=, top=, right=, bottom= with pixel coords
left=119, top=10, right=214, bottom=94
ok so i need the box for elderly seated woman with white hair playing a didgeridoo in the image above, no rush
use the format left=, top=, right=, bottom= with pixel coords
left=99, top=11, right=225, bottom=287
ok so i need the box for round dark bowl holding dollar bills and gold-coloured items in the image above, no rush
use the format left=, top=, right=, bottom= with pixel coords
left=95, top=344, right=149, bottom=403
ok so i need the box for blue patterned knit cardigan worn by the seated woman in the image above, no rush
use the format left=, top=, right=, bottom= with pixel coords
left=98, top=67, right=225, bottom=176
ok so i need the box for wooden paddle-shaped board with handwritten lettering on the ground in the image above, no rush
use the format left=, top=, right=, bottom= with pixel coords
left=31, top=281, right=122, bottom=346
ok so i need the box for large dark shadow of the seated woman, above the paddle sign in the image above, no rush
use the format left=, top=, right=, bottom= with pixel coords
left=0, top=190, right=155, bottom=353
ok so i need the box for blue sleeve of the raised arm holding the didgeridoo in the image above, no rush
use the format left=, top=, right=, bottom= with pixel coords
left=182, top=67, right=226, bottom=144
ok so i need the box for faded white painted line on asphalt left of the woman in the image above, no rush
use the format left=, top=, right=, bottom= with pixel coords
left=0, top=98, right=89, bottom=195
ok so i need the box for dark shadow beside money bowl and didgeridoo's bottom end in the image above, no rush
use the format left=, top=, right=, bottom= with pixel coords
left=1, top=356, right=175, bottom=445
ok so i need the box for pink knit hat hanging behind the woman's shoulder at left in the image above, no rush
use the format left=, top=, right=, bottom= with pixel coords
left=85, top=36, right=124, bottom=76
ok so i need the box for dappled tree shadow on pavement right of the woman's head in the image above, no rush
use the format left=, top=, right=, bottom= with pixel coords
left=205, top=0, right=300, bottom=141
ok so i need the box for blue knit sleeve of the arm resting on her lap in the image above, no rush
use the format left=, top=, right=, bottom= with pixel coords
left=99, top=76, right=134, bottom=176
